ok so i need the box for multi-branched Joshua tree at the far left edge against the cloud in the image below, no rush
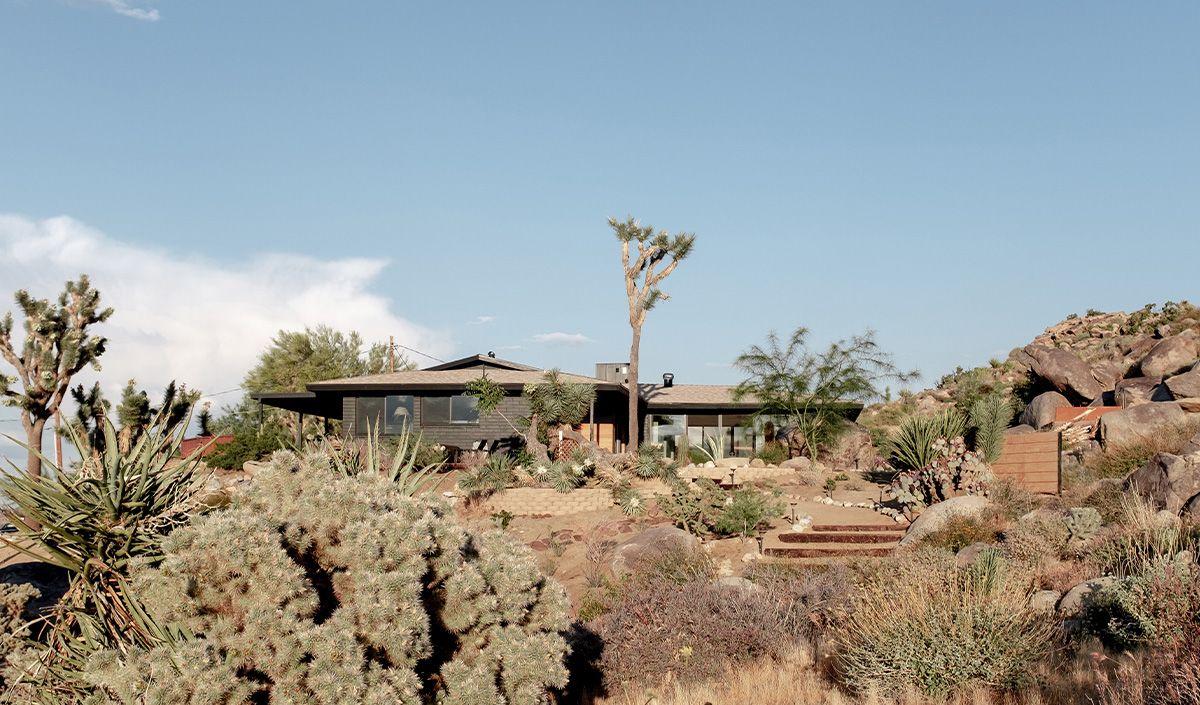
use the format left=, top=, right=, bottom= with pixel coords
left=0, top=275, right=113, bottom=477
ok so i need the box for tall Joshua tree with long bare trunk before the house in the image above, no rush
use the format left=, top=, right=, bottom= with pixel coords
left=608, top=216, right=696, bottom=450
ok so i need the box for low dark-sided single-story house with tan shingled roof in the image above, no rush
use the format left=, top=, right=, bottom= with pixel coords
left=251, top=355, right=862, bottom=457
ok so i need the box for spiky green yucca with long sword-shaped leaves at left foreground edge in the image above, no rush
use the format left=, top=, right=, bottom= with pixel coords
left=0, top=417, right=205, bottom=703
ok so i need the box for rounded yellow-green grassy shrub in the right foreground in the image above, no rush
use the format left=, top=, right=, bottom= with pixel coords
left=839, top=561, right=1056, bottom=697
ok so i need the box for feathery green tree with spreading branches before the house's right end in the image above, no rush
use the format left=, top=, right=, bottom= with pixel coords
left=733, top=327, right=919, bottom=458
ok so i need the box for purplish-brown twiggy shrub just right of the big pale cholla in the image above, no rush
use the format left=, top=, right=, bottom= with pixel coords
left=589, top=544, right=803, bottom=692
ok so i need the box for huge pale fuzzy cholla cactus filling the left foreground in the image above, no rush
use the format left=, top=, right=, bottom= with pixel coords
left=88, top=453, right=568, bottom=705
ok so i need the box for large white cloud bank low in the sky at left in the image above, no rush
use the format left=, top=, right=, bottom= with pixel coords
left=0, top=215, right=454, bottom=412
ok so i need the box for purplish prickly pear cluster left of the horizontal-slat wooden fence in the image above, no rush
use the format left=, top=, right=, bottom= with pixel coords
left=890, top=436, right=992, bottom=508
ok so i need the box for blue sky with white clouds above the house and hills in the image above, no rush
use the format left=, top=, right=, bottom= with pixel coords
left=0, top=0, right=1200, bottom=448
